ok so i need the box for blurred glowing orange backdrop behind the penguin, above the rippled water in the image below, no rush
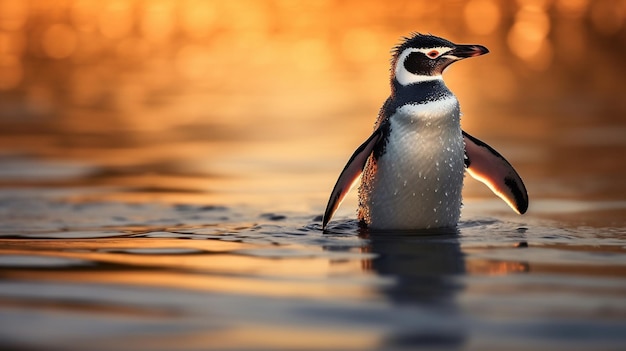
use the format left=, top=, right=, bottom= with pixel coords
left=0, top=0, right=626, bottom=210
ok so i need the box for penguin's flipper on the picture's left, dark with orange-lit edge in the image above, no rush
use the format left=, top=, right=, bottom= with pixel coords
left=322, top=128, right=382, bottom=230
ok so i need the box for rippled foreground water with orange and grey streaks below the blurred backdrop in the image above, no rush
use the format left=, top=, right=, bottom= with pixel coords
left=0, top=199, right=626, bottom=350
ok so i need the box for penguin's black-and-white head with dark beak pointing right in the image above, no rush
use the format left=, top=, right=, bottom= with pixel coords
left=391, top=33, right=489, bottom=85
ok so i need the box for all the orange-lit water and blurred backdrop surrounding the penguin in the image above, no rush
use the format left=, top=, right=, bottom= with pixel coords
left=0, top=0, right=626, bottom=350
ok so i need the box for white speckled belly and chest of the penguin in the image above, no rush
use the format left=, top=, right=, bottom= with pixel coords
left=359, top=98, right=465, bottom=229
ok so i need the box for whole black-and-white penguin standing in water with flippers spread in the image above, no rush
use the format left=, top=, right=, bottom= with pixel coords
left=322, top=33, right=528, bottom=230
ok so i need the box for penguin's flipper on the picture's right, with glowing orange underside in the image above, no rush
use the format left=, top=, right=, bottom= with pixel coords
left=463, top=131, right=528, bottom=214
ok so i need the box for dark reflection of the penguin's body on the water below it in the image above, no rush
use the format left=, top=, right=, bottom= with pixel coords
left=360, top=229, right=466, bottom=348
